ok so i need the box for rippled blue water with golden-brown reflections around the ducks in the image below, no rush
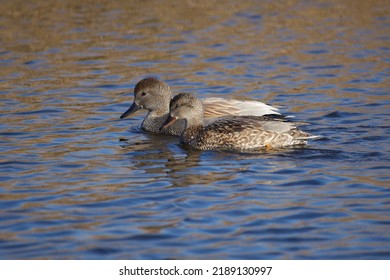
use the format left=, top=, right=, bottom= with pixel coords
left=0, top=0, right=390, bottom=259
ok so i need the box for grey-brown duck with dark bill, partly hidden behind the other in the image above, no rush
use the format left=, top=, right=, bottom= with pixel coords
left=120, top=77, right=281, bottom=136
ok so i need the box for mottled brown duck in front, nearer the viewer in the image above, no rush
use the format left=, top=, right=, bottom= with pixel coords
left=161, top=93, right=313, bottom=151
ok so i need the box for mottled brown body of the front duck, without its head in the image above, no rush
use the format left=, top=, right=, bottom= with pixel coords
left=180, top=116, right=310, bottom=150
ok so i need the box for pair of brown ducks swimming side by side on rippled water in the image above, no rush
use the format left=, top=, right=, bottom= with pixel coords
left=120, top=78, right=314, bottom=151
